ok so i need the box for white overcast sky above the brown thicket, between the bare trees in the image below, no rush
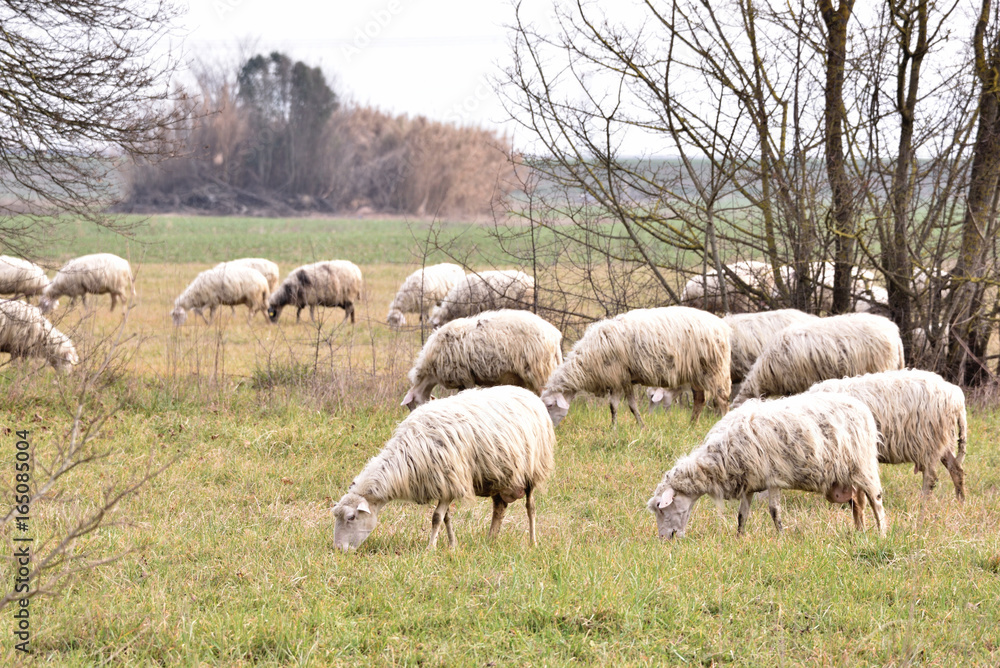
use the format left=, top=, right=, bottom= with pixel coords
left=181, top=0, right=551, bottom=138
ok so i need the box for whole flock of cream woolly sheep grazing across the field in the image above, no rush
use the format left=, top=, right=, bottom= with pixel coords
left=0, top=254, right=967, bottom=549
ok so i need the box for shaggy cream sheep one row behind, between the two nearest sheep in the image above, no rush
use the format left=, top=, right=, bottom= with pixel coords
left=542, top=306, right=732, bottom=425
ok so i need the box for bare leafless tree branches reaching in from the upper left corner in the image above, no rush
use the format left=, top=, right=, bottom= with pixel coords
left=0, top=0, right=180, bottom=256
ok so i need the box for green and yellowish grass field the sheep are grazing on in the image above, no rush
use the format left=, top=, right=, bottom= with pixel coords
left=0, top=217, right=1000, bottom=666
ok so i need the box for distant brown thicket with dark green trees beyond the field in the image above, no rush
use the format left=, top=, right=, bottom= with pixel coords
left=125, top=52, right=514, bottom=216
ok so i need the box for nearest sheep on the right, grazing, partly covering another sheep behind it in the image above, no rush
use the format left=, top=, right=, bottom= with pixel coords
left=647, top=393, right=887, bottom=539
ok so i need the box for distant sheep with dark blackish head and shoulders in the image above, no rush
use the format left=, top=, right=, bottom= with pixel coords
left=267, top=260, right=361, bottom=324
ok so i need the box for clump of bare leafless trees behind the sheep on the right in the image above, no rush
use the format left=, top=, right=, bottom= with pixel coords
left=501, top=0, right=1000, bottom=384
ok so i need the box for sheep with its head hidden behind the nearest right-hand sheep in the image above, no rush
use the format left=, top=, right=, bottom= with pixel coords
left=809, top=369, right=968, bottom=501
